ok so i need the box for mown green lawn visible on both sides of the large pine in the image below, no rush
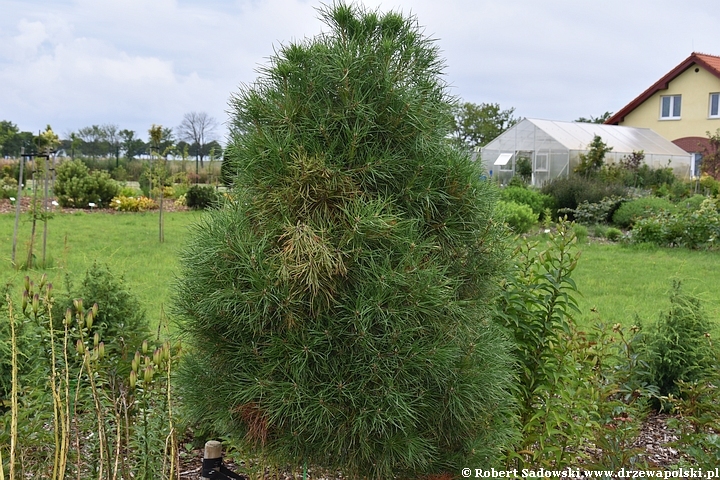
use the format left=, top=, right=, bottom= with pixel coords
left=5, top=212, right=720, bottom=334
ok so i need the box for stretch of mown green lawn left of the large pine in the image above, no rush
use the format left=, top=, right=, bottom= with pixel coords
left=0, top=212, right=201, bottom=327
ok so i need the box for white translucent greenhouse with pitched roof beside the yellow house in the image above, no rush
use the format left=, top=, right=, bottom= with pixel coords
left=480, top=118, right=694, bottom=186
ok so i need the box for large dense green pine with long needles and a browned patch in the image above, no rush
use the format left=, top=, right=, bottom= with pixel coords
left=175, top=3, right=516, bottom=478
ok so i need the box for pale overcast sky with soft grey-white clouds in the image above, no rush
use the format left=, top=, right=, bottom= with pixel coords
left=0, top=0, right=720, bottom=140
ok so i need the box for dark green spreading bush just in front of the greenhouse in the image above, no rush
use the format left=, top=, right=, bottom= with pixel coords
left=541, top=175, right=627, bottom=219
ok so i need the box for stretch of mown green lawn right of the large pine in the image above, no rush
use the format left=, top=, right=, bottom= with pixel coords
left=573, top=243, right=720, bottom=331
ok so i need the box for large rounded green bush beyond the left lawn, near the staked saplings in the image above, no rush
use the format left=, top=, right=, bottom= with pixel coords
left=54, top=160, right=120, bottom=208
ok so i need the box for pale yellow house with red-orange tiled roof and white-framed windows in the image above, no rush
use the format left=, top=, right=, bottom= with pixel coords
left=605, top=52, right=720, bottom=175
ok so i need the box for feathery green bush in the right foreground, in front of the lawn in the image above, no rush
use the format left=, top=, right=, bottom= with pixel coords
left=647, top=282, right=715, bottom=402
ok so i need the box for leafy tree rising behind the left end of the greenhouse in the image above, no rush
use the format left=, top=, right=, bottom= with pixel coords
left=452, top=102, right=518, bottom=148
